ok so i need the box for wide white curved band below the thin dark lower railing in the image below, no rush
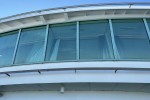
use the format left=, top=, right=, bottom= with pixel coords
left=0, top=72, right=150, bottom=85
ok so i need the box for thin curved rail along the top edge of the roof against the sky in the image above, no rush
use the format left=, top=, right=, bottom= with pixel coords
left=0, top=2, right=150, bottom=22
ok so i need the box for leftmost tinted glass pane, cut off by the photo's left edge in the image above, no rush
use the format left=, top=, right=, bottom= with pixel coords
left=0, top=32, right=18, bottom=65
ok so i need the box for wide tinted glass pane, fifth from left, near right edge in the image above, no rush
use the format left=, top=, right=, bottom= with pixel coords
left=112, top=19, right=150, bottom=59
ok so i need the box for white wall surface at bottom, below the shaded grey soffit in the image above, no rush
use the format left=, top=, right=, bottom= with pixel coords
left=0, top=91, right=150, bottom=100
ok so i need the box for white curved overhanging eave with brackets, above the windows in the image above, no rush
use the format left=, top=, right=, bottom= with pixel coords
left=0, top=4, right=150, bottom=33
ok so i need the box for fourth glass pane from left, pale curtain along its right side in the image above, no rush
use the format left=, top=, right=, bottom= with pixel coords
left=80, top=20, right=113, bottom=59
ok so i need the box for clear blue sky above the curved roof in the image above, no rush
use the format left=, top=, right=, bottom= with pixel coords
left=0, top=0, right=150, bottom=18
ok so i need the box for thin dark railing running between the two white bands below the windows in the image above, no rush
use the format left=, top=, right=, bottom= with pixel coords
left=0, top=67, right=150, bottom=77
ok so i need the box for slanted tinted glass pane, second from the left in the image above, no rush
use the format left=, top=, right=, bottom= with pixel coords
left=15, top=26, right=46, bottom=64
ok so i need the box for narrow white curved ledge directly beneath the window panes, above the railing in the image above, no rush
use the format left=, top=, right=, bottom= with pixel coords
left=0, top=61, right=150, bottom=72
